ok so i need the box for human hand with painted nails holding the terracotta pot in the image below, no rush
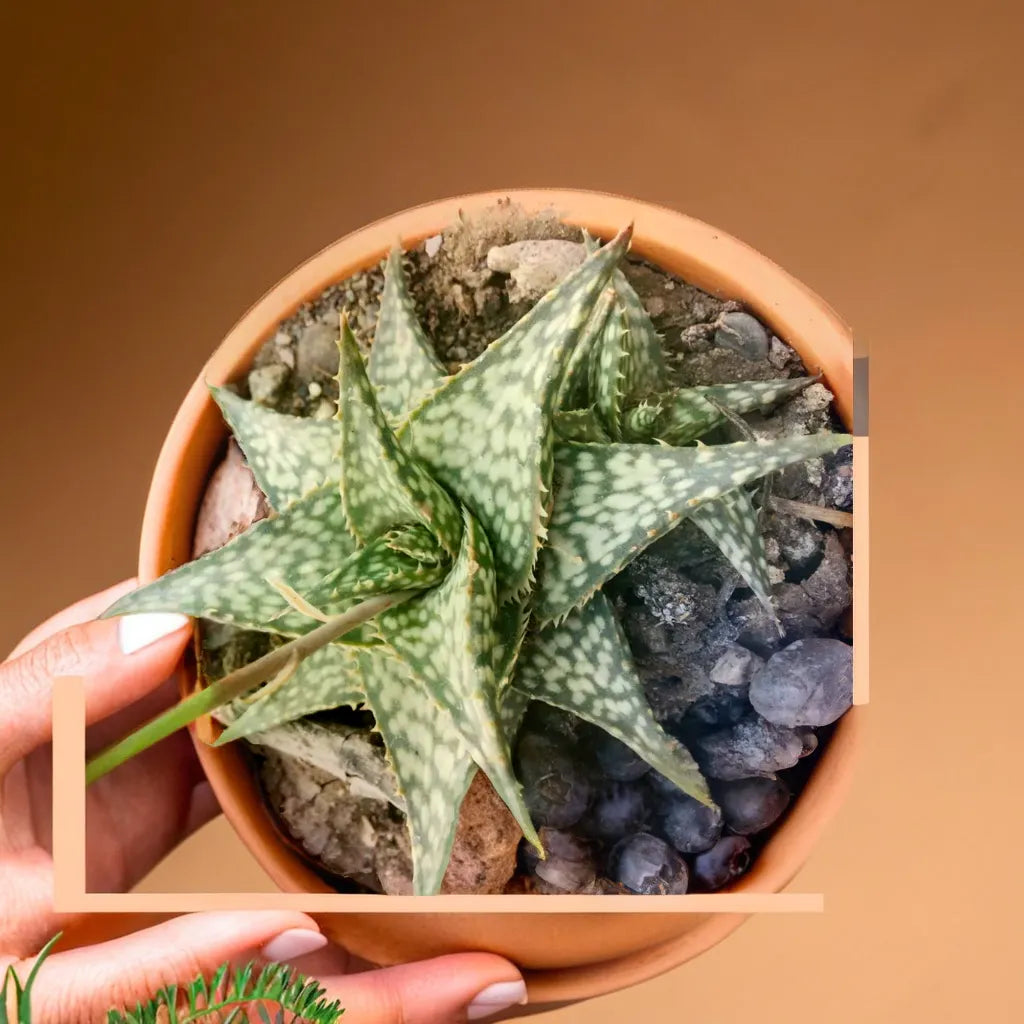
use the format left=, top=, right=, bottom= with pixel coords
left=0, top=581, right=525, bottom=1024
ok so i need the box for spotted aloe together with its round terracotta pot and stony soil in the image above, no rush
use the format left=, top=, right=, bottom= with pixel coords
left=90, top=193, right=852, bottom=1005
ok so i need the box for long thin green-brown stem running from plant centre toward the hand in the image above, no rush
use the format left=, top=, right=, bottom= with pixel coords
left=85, top=590, right=418, bottom=785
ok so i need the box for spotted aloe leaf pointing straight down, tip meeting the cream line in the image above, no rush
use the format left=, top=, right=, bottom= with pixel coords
left=358, top=651, right=476, bottom=895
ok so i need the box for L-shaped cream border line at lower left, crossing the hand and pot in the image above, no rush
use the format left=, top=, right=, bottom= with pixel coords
left=53, top=677, right=824, bottom=914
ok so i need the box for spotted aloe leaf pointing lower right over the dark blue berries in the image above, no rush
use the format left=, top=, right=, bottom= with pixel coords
left=513, top=594, right=712, bottom=804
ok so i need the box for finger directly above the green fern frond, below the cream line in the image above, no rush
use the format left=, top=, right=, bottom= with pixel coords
left=14, top=910, right=327, bottom=1024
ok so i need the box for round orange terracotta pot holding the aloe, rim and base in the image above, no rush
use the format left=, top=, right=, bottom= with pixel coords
left=132, top=190, right=861, bottom=1012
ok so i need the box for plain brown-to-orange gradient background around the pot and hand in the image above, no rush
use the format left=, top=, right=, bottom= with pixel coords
left=0, top=0, right=1024, bottom=1024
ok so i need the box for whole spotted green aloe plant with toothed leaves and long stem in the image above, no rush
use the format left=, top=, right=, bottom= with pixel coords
left=89, top=222, right=850, bottom=894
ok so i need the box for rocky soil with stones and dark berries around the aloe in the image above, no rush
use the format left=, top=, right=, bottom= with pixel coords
left=197, top=204, right=852, bottom=893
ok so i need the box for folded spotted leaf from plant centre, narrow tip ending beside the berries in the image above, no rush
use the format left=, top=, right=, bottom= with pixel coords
left=377, top=503, right=538, bottom=843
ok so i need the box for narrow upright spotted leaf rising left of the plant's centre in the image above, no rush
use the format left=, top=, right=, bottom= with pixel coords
left=338, top=317, right=462, bottom=554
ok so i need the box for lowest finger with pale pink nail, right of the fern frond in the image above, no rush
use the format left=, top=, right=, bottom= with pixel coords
left=319, top=952, right=526, bottom=1024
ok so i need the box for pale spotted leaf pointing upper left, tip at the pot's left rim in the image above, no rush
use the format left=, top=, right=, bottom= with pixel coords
left=210, top=387, right=341, bottom=512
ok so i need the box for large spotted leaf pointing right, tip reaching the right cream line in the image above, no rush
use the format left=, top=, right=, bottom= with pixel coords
left=534, top=432, right=851, bottom=624
